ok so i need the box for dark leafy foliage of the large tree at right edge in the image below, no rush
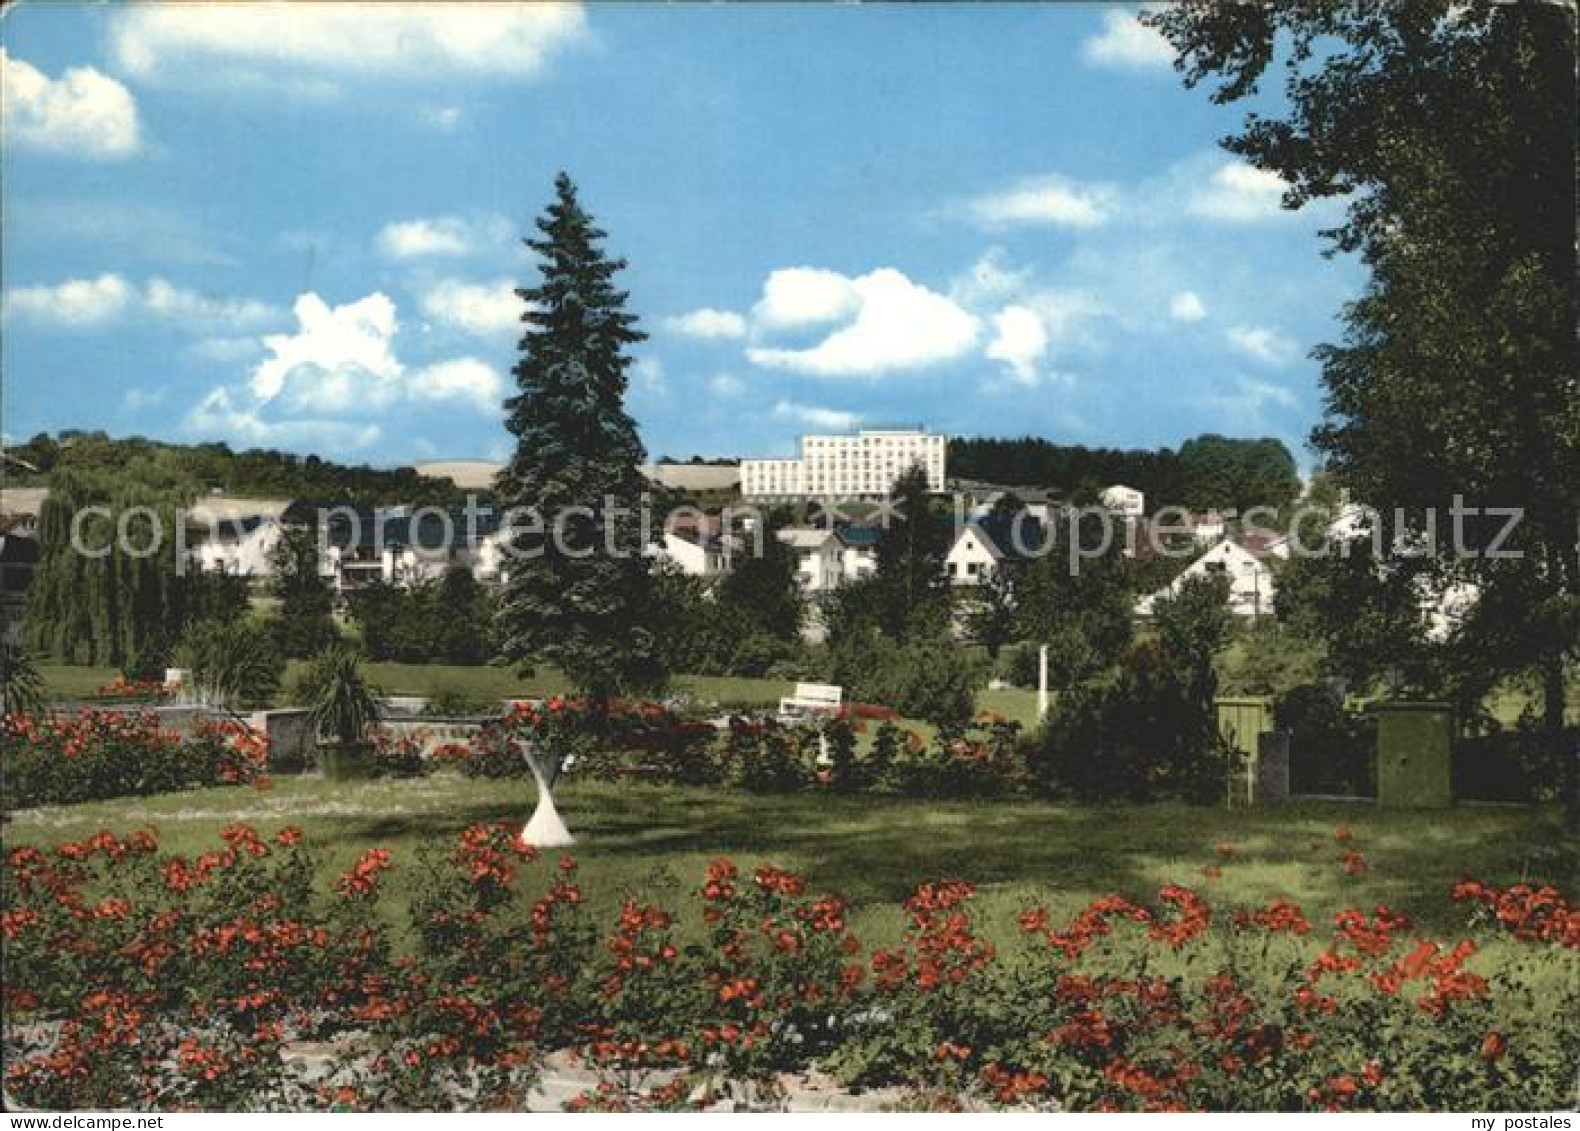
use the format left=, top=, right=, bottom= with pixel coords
left=1144, top=0, right=1580, bottom=727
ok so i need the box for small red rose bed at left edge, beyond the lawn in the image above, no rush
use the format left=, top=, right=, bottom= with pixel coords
left=0, top=709, right=269, bottom=809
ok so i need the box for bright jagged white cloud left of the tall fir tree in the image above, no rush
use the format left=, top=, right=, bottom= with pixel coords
left=250, top=291, right=403, bottom=409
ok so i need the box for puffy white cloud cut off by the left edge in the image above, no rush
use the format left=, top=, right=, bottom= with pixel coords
left=0, top=47, right=139, bottom=160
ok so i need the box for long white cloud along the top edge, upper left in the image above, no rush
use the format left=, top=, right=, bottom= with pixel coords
left=111, top=3, right=586, bottom=81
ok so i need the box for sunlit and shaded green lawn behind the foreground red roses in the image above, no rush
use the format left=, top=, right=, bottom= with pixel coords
left=5, top=772, right=1575, bottom=946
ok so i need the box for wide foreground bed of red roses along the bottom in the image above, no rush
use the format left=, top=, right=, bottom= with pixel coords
left=0, top=826, right=1580, bottom=1110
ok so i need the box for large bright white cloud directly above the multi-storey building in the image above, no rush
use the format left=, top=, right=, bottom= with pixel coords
left=746, top=267, right=981, bottom=376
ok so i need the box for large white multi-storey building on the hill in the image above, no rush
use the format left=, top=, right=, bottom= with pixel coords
left=741, top=428, right=946, bottom=499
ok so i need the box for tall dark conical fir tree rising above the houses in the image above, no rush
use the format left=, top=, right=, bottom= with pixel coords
left=499, top=174, right=664, bottom=700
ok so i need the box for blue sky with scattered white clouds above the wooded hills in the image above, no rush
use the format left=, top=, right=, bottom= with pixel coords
left=0, top=2, right=1364, bottom=466
